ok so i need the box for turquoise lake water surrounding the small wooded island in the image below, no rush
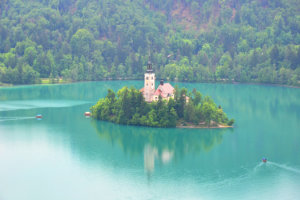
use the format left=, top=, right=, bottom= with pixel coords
left=0, top=81, right=300, bottom=200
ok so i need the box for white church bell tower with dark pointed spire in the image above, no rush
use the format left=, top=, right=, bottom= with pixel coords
left=144, top=60, right=155, bottom=102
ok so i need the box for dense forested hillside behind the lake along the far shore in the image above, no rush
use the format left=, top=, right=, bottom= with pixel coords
left=0, top=0, right=300, bottom=85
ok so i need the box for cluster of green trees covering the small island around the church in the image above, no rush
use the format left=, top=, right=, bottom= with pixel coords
left=91, top=87, right=234, bottom=127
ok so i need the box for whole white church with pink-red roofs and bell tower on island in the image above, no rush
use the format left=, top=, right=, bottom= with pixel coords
left=140, top=61, right=175, bottom=102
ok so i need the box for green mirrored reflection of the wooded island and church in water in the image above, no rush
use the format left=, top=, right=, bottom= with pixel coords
left=92, top=120, right=230, bottom=177
